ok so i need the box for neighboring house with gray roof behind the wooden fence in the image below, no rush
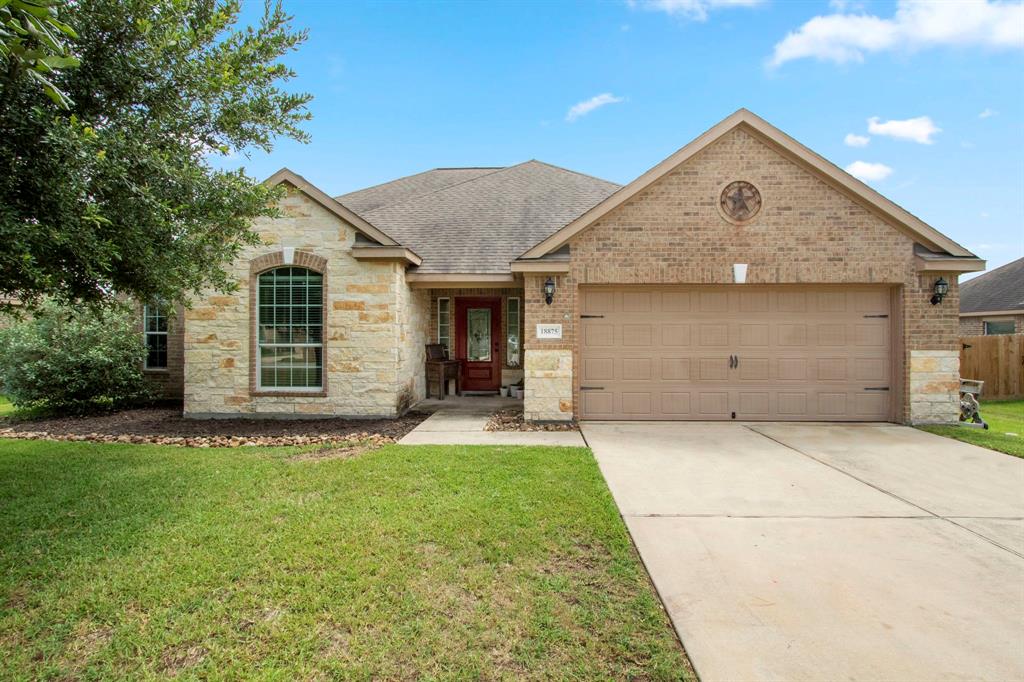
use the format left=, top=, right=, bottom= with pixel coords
left=961, top=258, right=1024, bottom=336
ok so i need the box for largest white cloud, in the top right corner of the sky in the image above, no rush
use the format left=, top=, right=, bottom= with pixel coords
left=768, top=0, right=1024, bottom=68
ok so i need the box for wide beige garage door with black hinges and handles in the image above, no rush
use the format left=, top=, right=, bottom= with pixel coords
left=580, top=285, right=892, bottom=421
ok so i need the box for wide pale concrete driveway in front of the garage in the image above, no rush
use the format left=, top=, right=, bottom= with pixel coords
left=583, top=422, right=1024, bottom=682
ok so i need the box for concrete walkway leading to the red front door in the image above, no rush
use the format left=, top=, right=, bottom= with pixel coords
left=398, top=396, right=587, bottom=447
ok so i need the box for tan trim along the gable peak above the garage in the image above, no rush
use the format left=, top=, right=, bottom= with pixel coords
left=521, top=109, right=977, bottom=259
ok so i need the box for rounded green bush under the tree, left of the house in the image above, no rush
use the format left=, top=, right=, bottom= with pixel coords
left=0, top=302, right=153, bottom=413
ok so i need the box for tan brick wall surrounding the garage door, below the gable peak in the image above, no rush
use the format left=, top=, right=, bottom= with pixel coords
left=524, top=122, right=959, bottom=422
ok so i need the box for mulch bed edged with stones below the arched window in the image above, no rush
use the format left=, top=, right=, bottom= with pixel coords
left=0, top=408, right=430, bottom=447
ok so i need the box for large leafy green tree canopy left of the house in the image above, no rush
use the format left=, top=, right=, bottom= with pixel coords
left=0, top=0, right=310, bottom=304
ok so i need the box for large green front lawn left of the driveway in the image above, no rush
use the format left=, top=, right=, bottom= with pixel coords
left=0, top=440, right=692, bottom=680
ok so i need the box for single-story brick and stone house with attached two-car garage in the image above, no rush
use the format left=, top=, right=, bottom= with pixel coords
left=144, top=110, right=984, bottom=423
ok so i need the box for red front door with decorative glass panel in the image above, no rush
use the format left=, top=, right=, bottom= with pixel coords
left=455, top=298, right=502, bottom=391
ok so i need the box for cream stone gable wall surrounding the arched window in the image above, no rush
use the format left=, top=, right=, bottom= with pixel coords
left=184, top=189, right=426, bottom=417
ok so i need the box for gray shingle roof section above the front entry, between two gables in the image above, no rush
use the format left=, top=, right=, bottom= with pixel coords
left=338, top=161, right=620, bottom=273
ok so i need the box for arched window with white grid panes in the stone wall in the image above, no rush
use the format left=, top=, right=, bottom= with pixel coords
left=256, top=267, right=324, bottom=391
